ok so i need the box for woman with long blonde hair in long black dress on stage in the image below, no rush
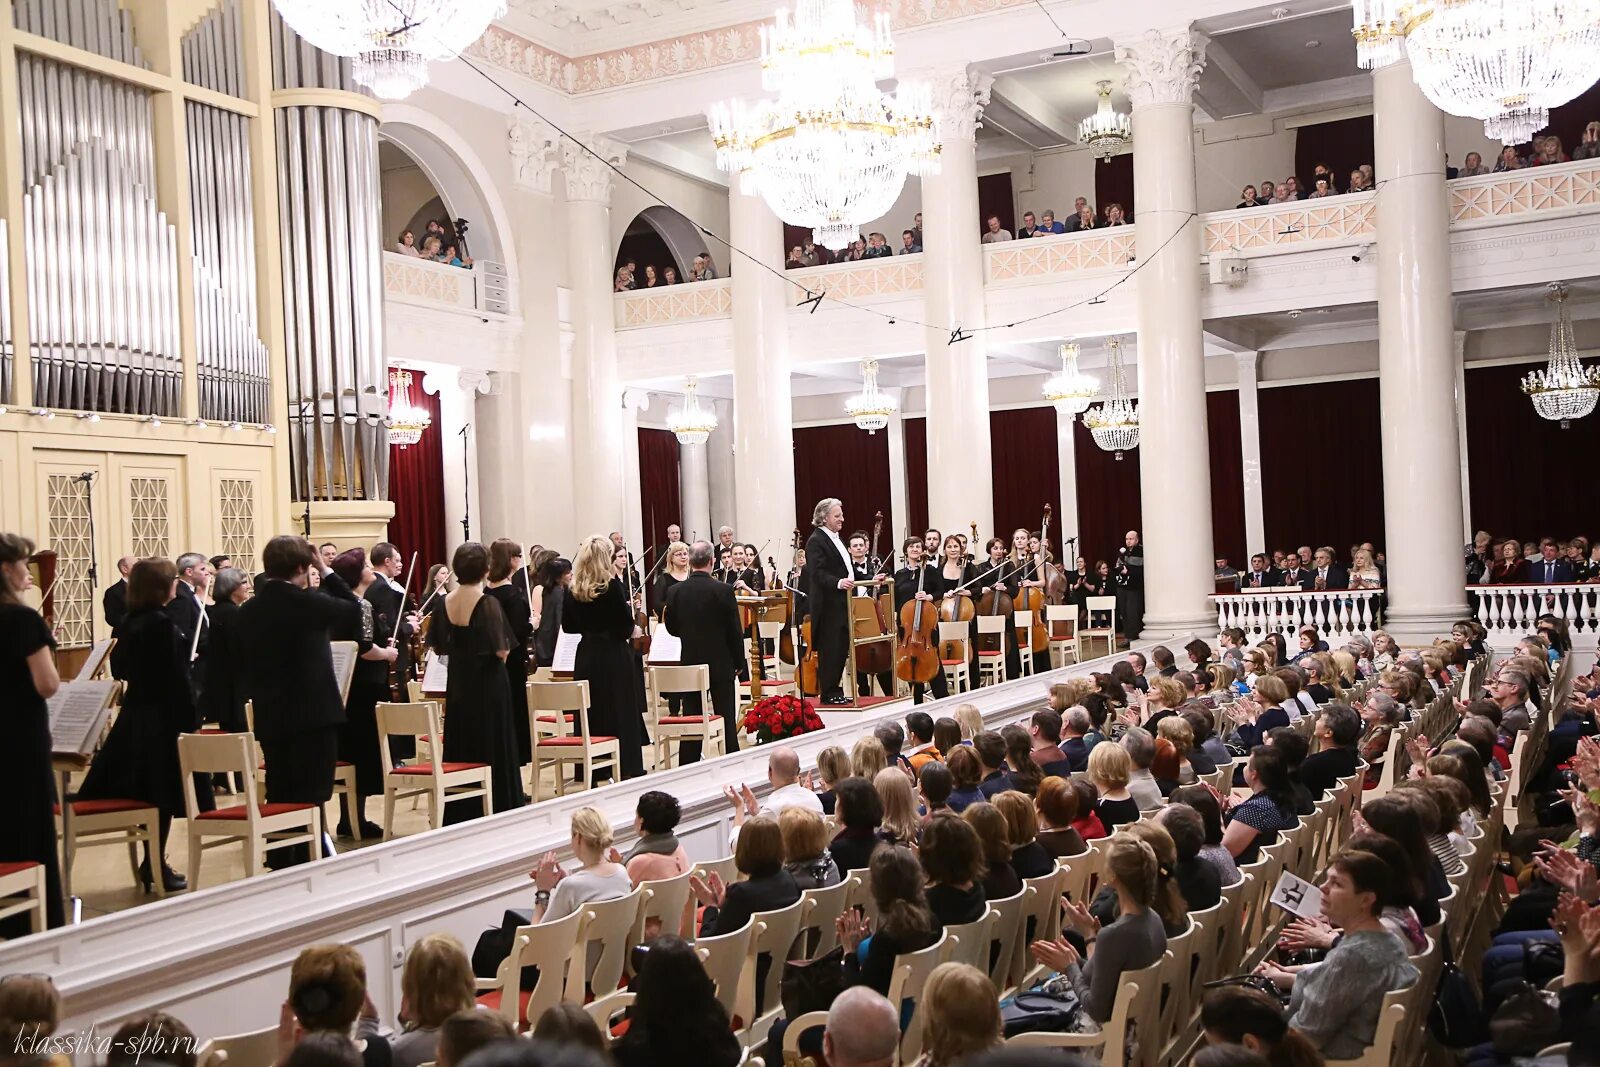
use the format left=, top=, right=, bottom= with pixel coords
left=562, top=534, right=643, bottom=777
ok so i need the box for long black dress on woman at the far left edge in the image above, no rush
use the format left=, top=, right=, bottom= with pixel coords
left=0, top=603, right=66, bottom=937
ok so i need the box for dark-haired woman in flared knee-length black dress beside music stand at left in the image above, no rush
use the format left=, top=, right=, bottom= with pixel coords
left=77, top=558, right=196, bottom=893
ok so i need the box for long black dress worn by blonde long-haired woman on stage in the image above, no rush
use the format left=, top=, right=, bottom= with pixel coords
left=562, top=577, right=645, bottom=777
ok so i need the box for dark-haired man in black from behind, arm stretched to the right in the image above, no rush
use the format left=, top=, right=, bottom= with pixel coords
left=235, top=534, right=360, bottom=865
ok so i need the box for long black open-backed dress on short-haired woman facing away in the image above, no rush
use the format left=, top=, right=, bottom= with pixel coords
left=427, top=597, right=526, bottom=822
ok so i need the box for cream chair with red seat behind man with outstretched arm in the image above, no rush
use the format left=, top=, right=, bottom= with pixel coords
left=178, top=733, right=322, bottom=889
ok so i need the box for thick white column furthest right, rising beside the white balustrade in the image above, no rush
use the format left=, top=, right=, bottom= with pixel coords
left=1373, top=62, right=1467, bottom=640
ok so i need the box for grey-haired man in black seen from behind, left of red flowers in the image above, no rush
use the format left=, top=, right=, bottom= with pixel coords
left=661, top=541, right=744, bottom=765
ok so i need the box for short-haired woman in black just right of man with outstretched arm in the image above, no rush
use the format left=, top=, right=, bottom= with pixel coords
left=322, top=549, right=400, bottom=838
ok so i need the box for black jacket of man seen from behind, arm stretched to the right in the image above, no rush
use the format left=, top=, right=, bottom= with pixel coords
left=235, top=581, right=362, bottom=741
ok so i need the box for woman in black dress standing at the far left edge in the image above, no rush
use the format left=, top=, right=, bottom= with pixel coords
left=0, top=533, right=66, bottom=937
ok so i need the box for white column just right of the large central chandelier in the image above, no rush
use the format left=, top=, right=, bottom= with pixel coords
left=917, top=66, right=995, bottom=530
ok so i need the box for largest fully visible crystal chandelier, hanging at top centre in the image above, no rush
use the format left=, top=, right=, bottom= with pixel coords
left=707, top=0, right=939, bottom=250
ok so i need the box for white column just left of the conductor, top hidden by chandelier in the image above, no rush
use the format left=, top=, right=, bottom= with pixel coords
left=728, top=191, right=796, bottom=559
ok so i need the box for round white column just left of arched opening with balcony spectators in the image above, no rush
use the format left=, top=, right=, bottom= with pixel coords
left=562, top=136, right=638, bottom=537
